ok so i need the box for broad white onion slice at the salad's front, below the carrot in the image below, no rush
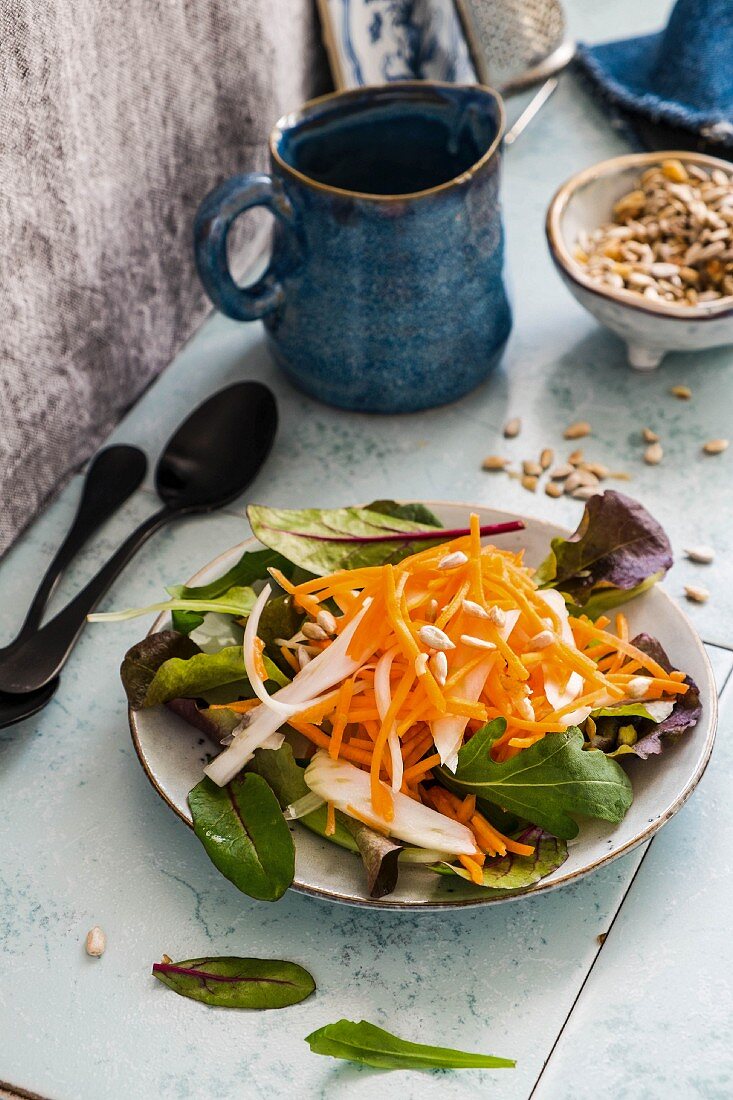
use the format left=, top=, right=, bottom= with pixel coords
left=305, top=752, right=475, bottom=856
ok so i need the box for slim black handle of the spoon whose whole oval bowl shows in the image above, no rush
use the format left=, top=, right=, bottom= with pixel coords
left=0, top=508, right=171, bottom=694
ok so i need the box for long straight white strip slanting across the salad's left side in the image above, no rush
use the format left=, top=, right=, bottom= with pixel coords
left=204, top=600, right=376, bottom=787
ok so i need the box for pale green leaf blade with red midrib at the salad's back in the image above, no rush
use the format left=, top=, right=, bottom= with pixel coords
left=247, top=505, right=445, bottom=576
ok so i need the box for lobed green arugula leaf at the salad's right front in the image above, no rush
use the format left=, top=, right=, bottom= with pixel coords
left=435, top=718, right=633, bottom=840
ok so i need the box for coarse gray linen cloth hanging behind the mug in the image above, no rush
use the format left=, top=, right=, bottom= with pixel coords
left=0, top=0, right=325, bottom=553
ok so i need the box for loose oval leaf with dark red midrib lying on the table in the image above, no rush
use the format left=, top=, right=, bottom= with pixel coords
left=153, top=955, right=316, bottom=1009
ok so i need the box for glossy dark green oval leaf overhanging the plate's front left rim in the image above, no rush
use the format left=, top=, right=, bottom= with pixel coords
left=188, top=772, right=295, bottom=901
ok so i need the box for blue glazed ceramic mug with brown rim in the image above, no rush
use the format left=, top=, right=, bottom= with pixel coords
left=195, top=81, right=512, bottom=413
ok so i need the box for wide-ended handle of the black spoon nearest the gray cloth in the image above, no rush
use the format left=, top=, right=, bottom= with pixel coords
left=8, top=444, right=147, bottom=648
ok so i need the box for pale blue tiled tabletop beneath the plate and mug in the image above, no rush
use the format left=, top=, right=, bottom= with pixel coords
left=0, top=0, right=733, bottom=1100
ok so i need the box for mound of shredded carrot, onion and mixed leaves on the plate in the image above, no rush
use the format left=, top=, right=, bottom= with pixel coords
left=96, top=492, right=700, bottom=900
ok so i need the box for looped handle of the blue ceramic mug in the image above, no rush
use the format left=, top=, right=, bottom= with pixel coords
left=194, top=172, right=297, bottom=321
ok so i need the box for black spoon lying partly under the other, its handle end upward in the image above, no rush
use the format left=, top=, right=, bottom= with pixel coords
left=0, top=444, right=147, bottom=729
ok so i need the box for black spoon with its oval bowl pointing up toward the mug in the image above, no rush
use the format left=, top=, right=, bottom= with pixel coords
left=0, top=382, right=277, bottom=704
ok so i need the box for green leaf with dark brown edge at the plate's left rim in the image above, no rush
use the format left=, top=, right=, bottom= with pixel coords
left=120, top=630, right=288, bottom=711
